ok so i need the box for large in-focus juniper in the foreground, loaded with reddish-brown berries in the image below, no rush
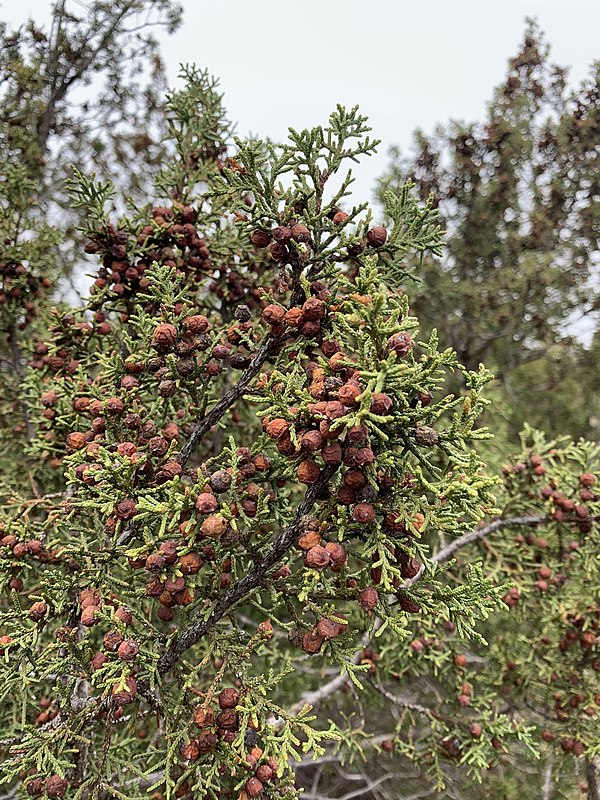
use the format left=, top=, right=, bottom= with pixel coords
left=0, top=69, right=593, bottom=800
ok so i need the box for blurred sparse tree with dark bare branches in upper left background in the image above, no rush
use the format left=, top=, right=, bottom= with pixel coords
left=0, top=0, right=181, bottom=289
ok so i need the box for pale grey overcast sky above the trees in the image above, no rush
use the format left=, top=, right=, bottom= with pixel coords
left=0, top=0, right=600, bottom=206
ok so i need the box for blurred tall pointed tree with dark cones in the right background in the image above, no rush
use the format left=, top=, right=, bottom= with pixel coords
left=379, top=18, right=600, bottom=435
